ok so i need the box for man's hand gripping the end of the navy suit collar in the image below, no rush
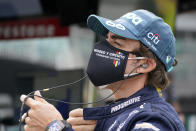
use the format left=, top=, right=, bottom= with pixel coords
left=67, top=109, right=97, bottom=131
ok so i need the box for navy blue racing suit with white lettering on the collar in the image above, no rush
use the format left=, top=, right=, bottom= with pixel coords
left=83, top=86, right=185, bottom=131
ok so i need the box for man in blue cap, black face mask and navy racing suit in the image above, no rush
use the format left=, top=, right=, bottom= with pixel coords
left=21, top=10, right=185, bottom=131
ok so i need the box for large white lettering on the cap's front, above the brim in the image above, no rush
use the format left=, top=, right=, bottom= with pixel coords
left=122, top=13, right=143, bottom=25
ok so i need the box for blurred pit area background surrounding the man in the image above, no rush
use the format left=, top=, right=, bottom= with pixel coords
left=0, top=0, right=196, bottom=131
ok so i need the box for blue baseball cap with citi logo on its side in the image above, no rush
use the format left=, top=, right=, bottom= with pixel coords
left=87, top=9, right=176, bottom=72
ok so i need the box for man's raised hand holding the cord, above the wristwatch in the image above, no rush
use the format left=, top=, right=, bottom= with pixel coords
left=20, top=91, right=63, bottom=131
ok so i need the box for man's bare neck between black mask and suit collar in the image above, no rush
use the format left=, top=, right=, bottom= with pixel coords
left=108, top=74, right=147, bottom=100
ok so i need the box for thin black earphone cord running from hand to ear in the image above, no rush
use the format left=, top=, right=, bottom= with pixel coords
left=19, top=65, right=141, bottom=131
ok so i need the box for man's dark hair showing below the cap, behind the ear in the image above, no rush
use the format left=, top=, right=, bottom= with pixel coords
left=139, top=44, right=170, bottom=89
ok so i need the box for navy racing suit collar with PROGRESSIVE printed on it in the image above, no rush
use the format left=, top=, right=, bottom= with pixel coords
left=83, top=86, right=159, bottom=120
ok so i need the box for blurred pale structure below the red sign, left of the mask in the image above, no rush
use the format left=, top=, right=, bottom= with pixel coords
left=0, top=25, right=95, bottom=71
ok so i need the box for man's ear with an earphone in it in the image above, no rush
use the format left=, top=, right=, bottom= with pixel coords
left=137, top=58, right=157, bottom=73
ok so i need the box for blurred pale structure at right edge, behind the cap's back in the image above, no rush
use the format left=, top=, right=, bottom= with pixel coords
left=174, top=11, right=196, bottom=97
